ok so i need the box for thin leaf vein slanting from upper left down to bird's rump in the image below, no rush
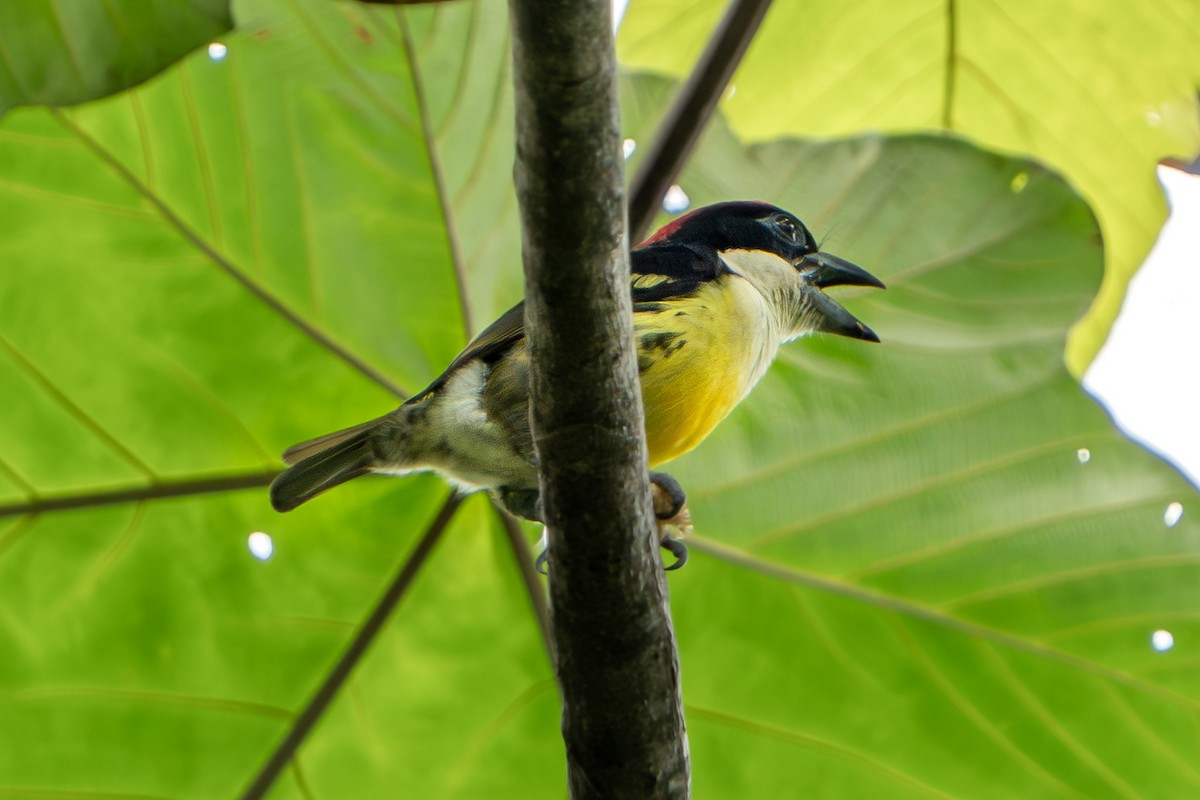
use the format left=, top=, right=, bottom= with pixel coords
left=49, top=108, right=408, bottom=397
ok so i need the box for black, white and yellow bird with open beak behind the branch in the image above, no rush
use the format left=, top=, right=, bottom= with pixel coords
left=270, top=200, right=884, bottom=569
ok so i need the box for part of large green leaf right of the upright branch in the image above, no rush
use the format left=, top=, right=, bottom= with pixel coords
left=629, top=82, right=1200, bottom=798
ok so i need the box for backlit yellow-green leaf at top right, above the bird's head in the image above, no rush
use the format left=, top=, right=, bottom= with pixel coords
left=619, top=0, right=1200, bottom=375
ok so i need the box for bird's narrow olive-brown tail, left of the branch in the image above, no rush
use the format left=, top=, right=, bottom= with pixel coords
left=271, top=414, right=400, bottom=511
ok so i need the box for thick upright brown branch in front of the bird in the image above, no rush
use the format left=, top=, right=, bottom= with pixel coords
left=509, top=0, right=689, bottom=800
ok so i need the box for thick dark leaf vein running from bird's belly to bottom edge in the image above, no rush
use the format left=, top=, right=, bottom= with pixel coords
left=241, top=493, right=462, bottom=800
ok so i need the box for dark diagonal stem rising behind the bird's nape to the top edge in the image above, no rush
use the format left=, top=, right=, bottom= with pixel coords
left=629, top=0, right=770, bottom=242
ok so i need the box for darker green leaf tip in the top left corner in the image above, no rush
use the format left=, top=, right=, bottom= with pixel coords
left=0, top=0, right=233, bottom=115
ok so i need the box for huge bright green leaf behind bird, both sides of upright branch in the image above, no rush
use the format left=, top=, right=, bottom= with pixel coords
left=0, top=0, right=1200, bottom=798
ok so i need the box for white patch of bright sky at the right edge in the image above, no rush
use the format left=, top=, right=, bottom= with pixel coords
left=1084, top=167, right=1200, bottom=486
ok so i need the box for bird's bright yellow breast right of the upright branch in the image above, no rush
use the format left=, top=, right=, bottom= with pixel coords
left=634, top=277, right=779, bottom=467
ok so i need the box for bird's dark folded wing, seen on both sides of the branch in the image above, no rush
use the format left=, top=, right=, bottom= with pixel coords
left=408, top=243, right=728, bottom=403
